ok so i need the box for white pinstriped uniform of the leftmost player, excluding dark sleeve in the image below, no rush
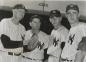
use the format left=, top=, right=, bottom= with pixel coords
left=0, top=18, right=25, bottom=62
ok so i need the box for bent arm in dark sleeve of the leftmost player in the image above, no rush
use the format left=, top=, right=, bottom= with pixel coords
left=1, top=34, right=23, bottom=49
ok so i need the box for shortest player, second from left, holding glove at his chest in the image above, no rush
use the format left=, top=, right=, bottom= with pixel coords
left=22, top=15, right=49, bottom=62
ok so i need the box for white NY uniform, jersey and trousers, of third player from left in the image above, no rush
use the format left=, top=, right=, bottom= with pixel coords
left=47, top=26, right=68, bottom=62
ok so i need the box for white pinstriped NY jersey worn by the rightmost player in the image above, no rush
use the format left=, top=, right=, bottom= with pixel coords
left=61, top=22, right=86, bottom=62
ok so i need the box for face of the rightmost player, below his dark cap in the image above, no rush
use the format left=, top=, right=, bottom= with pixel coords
left=66, top=9, right=79, bottom=24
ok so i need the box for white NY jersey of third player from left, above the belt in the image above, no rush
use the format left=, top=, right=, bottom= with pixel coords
left=47, top=26, right=68, bottom=57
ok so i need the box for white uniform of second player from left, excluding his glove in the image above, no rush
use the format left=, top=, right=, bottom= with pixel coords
left=22, top=30, right=49, bottom=62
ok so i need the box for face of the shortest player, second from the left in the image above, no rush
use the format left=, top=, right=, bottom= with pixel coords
left=30, top=18, right=41, bottom=30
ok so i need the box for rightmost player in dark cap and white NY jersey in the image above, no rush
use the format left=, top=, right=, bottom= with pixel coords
left=61, top=4, right=86, bottom=62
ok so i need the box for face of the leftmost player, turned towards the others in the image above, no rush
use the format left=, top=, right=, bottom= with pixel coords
left=13, top=9, right=25, bottom=21
